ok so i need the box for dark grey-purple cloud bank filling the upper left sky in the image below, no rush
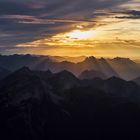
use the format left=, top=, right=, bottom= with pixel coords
left=0, top=0, right=135, bottom=54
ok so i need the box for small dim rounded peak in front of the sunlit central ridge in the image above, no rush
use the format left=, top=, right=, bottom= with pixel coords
left=79, top=70, right=107, bottom=79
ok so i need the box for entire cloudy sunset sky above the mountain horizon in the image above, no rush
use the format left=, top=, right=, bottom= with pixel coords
left=0, top=0, right=140, bottom=59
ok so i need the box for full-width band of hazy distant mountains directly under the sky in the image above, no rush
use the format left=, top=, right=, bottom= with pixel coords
left=0, top=54, right=140, bottom=81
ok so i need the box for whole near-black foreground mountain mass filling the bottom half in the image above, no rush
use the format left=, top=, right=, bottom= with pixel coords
left=0, top=67, right=140, bottom=140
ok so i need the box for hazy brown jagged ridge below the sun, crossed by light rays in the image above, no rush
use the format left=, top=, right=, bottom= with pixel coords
left=48, top=57, right=118, bottom=78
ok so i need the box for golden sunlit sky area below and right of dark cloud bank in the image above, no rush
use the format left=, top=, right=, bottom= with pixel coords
left=16, top=0, right=140, bottom=57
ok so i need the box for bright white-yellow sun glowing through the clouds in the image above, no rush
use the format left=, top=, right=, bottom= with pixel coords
left=67, top=30, right=96, bottom=40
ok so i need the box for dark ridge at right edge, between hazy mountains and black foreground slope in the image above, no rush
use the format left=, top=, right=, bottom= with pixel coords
left=83, top=77, right=140, bottom=105
